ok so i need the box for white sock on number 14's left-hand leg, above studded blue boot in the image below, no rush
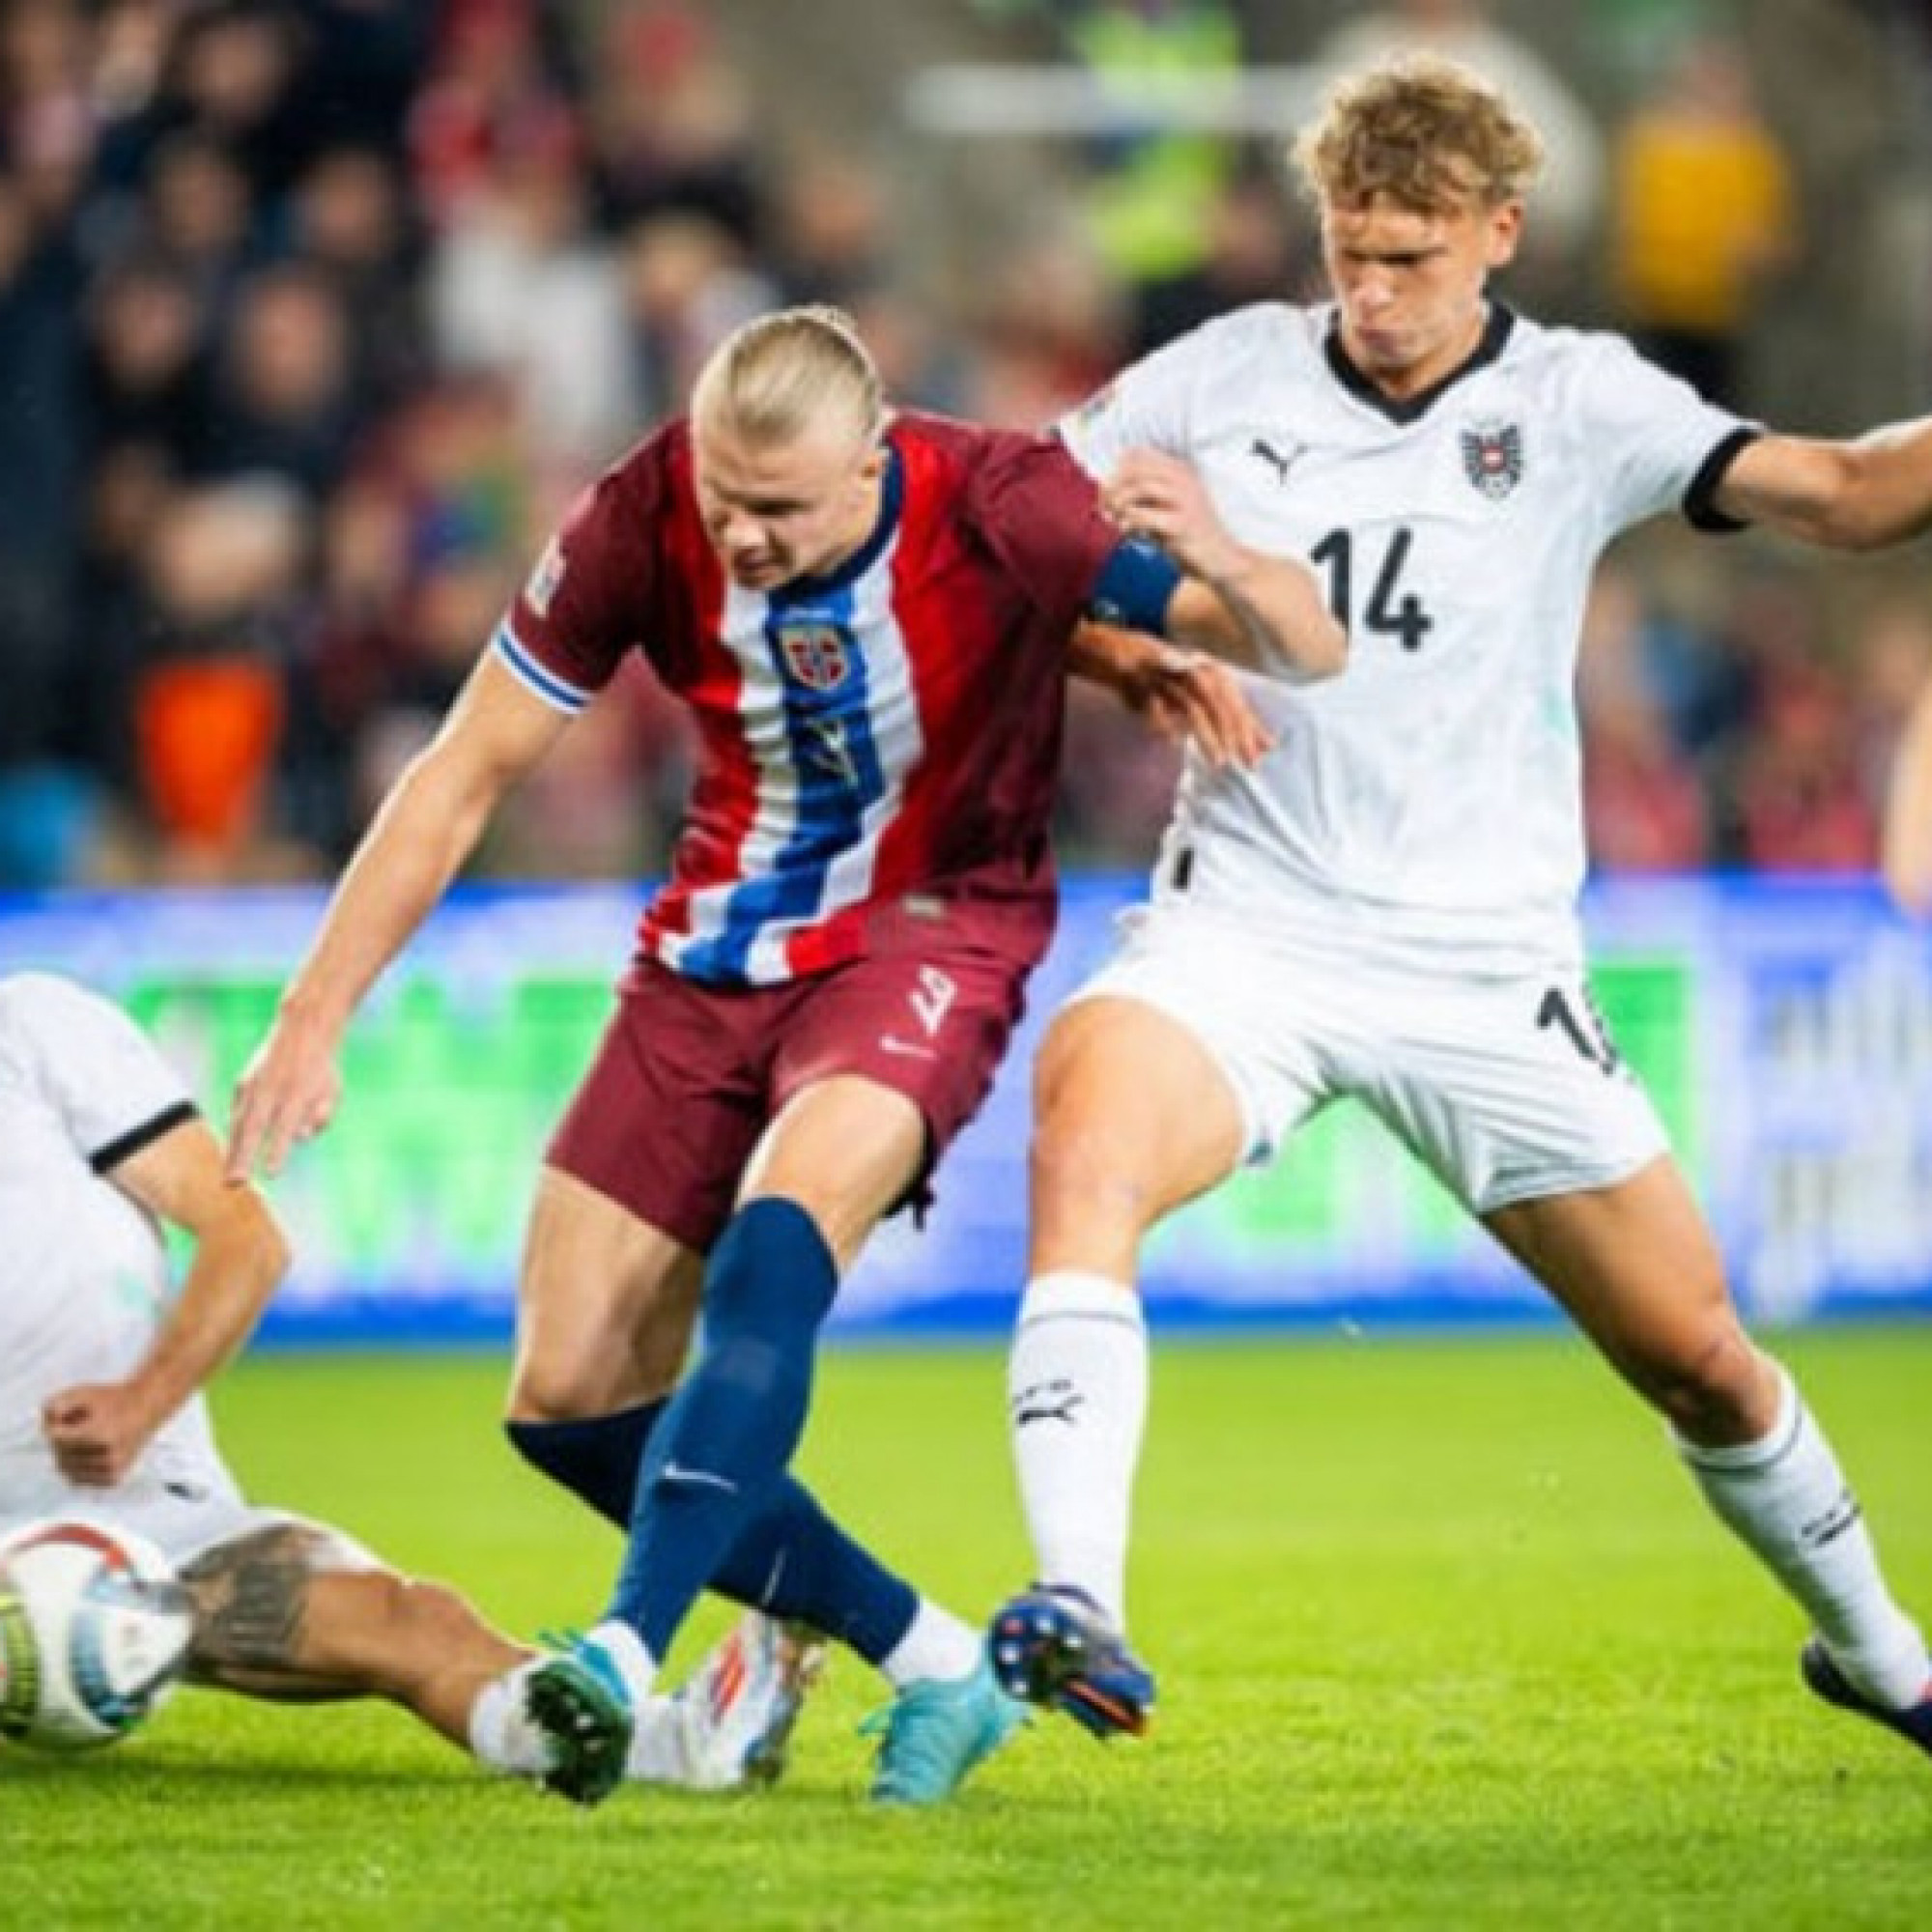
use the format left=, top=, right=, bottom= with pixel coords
left=1007, top=1269, right=1148, bottom=1631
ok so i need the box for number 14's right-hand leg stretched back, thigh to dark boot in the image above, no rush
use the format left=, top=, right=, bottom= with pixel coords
left=1486, top=1159, right=1932, bottom=1750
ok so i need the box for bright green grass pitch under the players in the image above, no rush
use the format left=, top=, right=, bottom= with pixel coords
left=0, top=1325, right=1932, bottom=1932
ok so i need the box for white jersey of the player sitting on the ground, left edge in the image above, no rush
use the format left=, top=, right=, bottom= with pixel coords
left=0, top=974, right=213, bottom=1515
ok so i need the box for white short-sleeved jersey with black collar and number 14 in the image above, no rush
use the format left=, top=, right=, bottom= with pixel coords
left=1061, top=303, right=1754, bottom=972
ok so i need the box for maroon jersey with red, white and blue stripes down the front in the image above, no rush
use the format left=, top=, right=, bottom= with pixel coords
left=491, top=415, right=1119, bottom=985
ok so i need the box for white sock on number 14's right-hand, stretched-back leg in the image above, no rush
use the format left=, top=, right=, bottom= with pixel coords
left=1677, top=1364, right=1932, bottom=1710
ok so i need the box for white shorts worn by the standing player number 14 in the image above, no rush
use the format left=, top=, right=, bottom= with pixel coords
left=1072, top=904, right=1669, bottom=1213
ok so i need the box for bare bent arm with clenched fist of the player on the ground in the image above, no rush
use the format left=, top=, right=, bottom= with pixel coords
left=41, top=1119, right=288, bottom=1488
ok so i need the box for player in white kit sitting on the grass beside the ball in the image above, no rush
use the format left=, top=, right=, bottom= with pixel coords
left=0, top=974, right=823, bottom=1787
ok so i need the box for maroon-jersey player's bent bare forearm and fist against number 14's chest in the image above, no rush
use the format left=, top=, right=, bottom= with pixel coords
left=1101, top=450, right=1349, bottom=680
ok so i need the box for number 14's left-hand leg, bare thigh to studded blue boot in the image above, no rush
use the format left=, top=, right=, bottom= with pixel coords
left=989, top=995, right=1242, bottom=1737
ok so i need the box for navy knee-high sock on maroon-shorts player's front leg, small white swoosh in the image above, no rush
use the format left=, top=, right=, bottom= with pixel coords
left=607, top=1198, right=838, bottom=1660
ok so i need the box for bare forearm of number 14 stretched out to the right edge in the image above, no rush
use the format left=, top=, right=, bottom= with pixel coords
left=1714, top=417, right=1932, bottom=551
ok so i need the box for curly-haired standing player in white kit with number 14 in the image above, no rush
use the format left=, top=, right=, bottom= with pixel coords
left=991, top=60, right=1932, bottom=1750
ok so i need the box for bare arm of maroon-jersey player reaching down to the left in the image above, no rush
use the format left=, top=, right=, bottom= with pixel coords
left=228, top=657, right=570, bottom=1180
